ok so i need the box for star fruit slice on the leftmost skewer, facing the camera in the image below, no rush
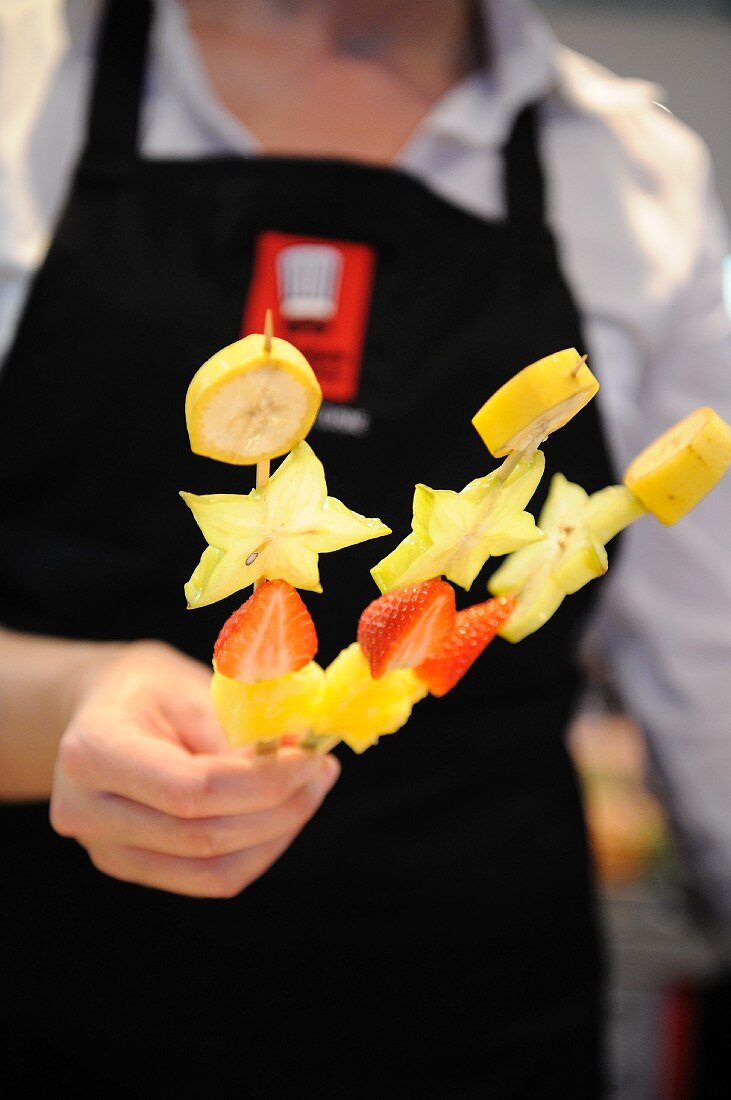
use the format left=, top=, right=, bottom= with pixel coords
left=180, top=442, right=390, bottom=607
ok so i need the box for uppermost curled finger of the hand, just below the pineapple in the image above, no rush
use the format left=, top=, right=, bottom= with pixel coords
left=57, top=723, right=337, bottom=820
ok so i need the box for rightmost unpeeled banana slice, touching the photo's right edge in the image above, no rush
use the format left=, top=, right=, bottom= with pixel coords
left=623, top=408, right=731, bottom=526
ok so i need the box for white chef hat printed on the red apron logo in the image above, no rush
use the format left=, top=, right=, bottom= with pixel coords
left=277, top=244, right=343, bottom=323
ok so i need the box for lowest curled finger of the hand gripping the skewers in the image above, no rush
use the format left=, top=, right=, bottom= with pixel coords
left=89, top=831, right=298, bottom=898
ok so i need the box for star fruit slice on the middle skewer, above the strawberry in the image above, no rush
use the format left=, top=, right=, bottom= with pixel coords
left=370, top=451, right=545, bottom=592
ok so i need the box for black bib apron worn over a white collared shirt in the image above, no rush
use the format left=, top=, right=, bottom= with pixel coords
left=0, top=0, right=612, bottom=1100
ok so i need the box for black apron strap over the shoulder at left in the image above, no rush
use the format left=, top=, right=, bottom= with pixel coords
left=84, top=0, right=153, bottom=164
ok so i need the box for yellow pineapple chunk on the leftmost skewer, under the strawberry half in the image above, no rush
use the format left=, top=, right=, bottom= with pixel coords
left=211, top=661, right=324, bottom=747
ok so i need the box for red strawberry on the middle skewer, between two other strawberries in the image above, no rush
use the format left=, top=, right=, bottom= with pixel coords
left=357, top=580, right=455, bottom=680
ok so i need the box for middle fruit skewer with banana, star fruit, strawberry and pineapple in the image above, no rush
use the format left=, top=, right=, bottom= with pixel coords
left=296, top=348, right=599, bottom=752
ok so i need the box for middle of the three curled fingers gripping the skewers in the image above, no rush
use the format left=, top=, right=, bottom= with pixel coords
left=66, top=768, right=336, bottom=859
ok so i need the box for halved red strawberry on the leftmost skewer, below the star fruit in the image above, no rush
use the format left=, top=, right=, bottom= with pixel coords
left=213, top=581, right=318, bottom=684
